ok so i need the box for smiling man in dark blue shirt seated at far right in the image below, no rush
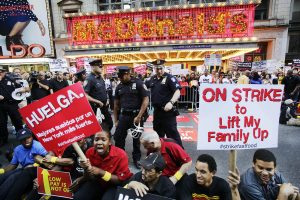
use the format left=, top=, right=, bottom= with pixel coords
left=239, top=149, right=300, bottom=200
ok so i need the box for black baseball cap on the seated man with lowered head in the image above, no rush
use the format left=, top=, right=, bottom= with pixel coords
left=140, top=153, right=166, bottom=171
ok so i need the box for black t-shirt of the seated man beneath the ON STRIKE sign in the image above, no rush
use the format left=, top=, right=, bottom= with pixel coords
left=177, top=174, right=232, bottom=200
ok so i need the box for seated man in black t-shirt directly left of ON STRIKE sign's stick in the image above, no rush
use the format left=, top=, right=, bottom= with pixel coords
left=176, top=154, right=232, bottom=200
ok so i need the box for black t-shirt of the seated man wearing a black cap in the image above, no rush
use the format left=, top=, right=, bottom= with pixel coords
left=128, top=172, right=176, bottom=198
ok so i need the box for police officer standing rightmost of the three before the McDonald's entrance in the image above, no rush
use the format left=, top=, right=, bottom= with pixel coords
left=146, top=59, right=182, bottom=146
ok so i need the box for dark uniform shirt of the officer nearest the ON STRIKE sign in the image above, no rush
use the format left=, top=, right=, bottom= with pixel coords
left=146, top=73, right=181, bottom=108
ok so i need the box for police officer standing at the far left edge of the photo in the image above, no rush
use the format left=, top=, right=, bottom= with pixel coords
left=0, top=67, right=23, bottom=146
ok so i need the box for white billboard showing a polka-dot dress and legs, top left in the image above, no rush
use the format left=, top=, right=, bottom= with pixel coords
left=0, top=0, right=54, bottom=59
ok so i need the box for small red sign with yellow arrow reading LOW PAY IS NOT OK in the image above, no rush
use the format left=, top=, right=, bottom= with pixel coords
left=37, top=167, right=73, bottom=199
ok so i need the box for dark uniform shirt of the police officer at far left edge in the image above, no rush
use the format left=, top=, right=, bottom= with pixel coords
left=0, top=77, right=21, bottom=103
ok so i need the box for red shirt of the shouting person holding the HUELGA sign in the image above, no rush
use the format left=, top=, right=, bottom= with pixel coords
left=86, top=145, right=132, bottom=182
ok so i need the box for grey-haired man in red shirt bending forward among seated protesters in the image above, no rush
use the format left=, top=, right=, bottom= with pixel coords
left=140, top=131, right=192, bottom=185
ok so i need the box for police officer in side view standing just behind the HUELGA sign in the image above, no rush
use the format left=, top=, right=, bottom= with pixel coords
left=83, top=59, right=113, bottom=130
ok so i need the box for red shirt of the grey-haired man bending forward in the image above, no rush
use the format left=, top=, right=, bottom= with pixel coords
left=160, top=138, right=192, bottom=176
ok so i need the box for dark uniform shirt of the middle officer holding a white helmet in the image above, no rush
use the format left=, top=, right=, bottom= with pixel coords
left=115, top=79, right=148, bottom=110
